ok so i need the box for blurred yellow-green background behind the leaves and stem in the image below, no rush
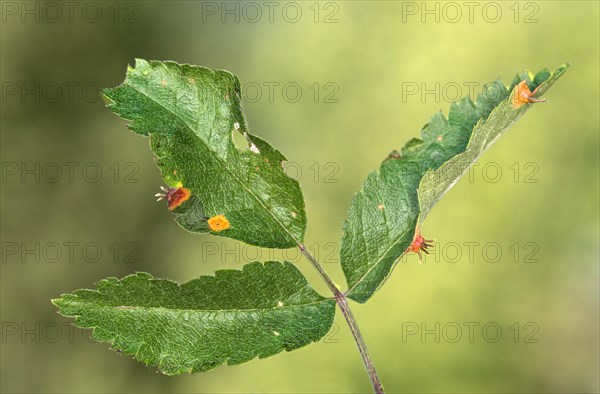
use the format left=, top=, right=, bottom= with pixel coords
left=0, top=1, right=600, bottom=393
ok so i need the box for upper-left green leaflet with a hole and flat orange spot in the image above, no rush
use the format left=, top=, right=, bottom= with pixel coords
left=104, top=59, right=306, bottom=248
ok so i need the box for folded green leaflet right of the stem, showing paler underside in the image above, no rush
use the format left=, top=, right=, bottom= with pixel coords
left=340, top=65, right=568, bottom=302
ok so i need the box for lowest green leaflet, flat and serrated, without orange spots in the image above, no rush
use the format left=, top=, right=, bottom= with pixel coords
left=52, top=262, right=335, bottom=375
